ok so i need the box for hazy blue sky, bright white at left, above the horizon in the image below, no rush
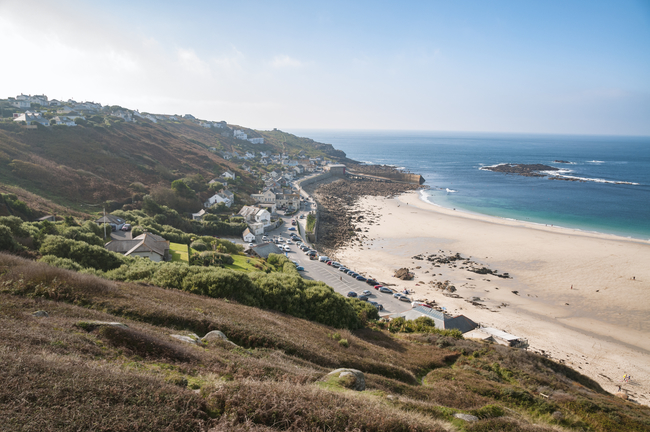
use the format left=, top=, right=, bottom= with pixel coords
left=0, top=0, right=650, bottom=136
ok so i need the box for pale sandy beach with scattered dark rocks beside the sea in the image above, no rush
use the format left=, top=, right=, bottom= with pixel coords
left=336, top=192, right=650, bottom=405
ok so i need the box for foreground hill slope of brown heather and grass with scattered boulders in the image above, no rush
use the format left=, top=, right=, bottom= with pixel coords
left=0, top=254, right=650, bottom=431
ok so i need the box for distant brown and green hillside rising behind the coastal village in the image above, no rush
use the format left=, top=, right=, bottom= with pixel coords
left=0, top=107, right=345, bottom=211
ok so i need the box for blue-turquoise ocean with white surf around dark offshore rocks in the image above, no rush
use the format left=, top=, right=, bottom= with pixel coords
left=290, top=130, right=650, bottom=239
